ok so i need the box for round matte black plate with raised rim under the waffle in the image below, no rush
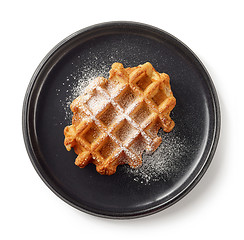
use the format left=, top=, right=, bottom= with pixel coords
left=23, top=22, right=220, bottom=218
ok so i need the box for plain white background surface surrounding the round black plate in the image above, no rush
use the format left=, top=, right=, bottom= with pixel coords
left=0, top=0, right=244, bottom=239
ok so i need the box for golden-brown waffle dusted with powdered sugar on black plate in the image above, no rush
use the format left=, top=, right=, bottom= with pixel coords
left=64, top=62, right=176, bottom=175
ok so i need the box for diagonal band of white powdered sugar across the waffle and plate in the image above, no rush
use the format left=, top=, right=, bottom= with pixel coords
left=64, top=61, right=182, bottom=184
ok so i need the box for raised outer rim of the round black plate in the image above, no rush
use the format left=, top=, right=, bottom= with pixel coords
left=22, top=21, right=221, bottom=219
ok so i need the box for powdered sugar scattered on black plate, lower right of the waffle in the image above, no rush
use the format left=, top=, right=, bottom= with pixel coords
left=124, top=130, right=189, bottom=184
